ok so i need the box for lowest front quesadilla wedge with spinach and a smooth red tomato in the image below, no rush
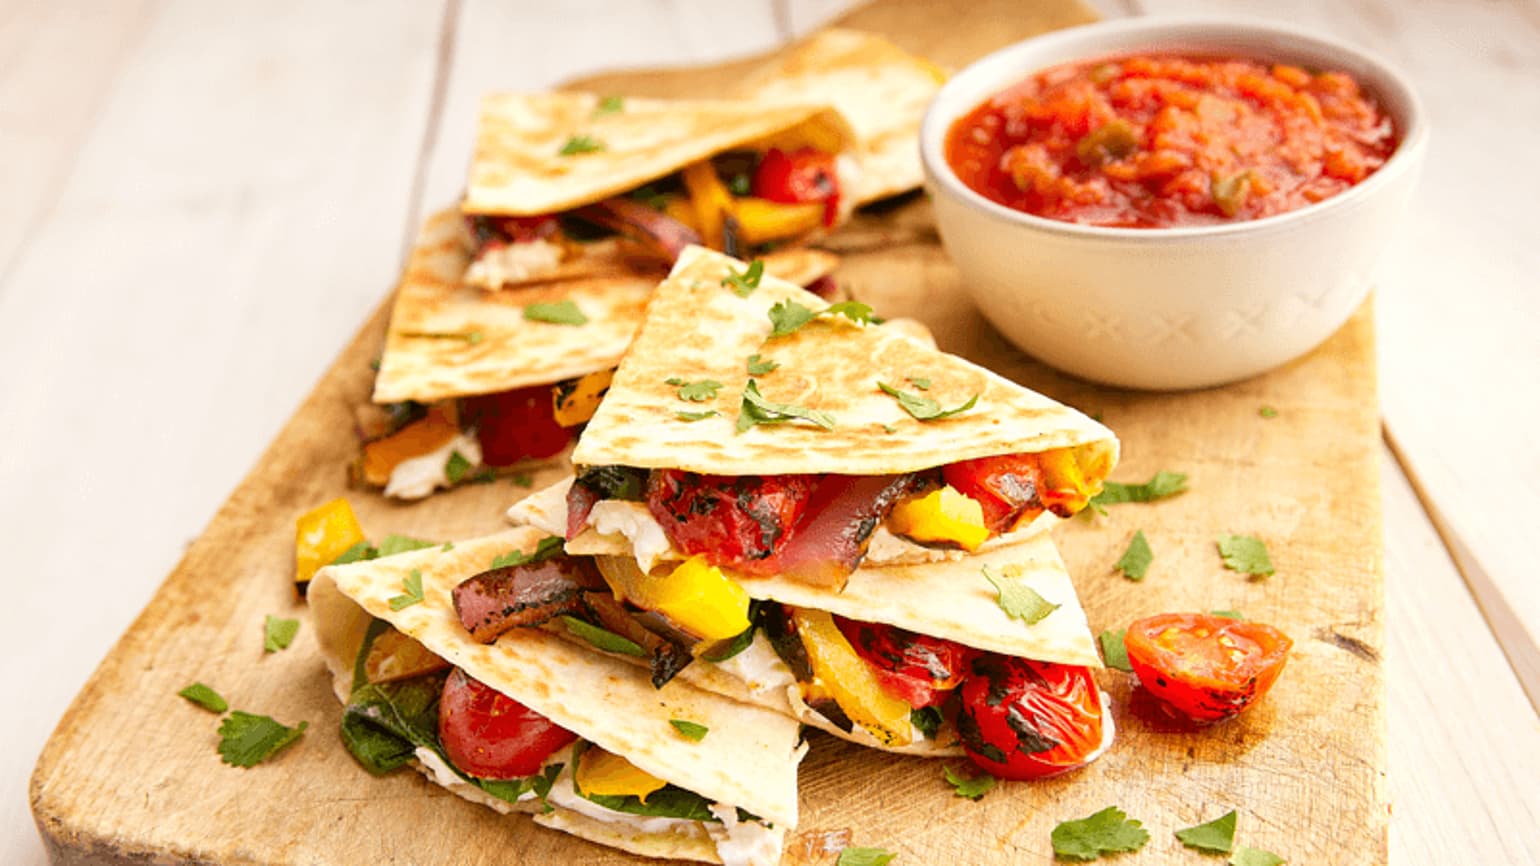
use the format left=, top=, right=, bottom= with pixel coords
left=310, top=529, right=805, bottom=866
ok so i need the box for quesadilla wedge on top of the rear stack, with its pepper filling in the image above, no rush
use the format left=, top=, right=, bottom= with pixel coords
left=462, top=92, right=861, bottom=290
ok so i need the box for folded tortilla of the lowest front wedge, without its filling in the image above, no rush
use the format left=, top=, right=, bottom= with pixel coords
left=310, top=529, right=805, bottom=838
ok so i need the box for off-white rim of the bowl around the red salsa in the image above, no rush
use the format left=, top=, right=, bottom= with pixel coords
left=919, top=15, right=1428, bottom=243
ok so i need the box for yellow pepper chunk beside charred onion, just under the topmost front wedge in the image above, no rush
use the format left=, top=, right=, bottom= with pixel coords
left=598, top=556, right=748, bottom=641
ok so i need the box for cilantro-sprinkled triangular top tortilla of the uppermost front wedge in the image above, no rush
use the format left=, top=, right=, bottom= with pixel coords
left=573, top=247, right=1118, bottom=482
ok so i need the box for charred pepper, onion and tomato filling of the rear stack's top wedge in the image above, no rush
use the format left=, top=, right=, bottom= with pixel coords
left=467, top=148, right=841, bottom=267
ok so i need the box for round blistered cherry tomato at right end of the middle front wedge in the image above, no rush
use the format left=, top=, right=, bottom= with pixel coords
left=958, top=653, right=1103, bottom=778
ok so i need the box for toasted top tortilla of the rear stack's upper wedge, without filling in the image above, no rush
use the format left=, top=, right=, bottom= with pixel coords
left=460, top=92, right=855, bottom=216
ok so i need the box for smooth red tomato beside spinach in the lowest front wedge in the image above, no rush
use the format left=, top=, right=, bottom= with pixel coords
left=439, top=667, right=578, bottom=778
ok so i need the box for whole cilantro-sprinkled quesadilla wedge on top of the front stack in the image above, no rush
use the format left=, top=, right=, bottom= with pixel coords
left=548, top=248, right=1118, bottom=587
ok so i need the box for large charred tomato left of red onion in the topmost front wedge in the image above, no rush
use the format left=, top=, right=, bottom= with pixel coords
left=647, top=468, right=818, bottom=567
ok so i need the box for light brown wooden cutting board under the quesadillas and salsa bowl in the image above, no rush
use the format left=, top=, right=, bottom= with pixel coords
left=31, top=0, right=1389, bottom=866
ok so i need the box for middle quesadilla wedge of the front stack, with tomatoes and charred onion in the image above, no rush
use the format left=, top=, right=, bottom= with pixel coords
left=454, top=505, right=1113, bottom=777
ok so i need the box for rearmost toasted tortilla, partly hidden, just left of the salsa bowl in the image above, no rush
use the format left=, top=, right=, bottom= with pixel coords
left=732, top=28, right=947, bottom=205
